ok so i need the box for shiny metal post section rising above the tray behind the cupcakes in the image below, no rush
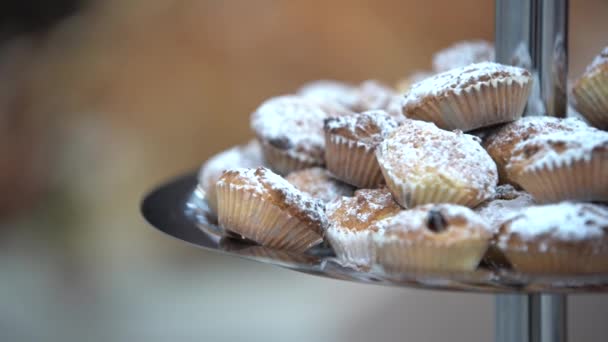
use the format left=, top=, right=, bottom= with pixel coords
left=495, top=0, right=568, bottom=117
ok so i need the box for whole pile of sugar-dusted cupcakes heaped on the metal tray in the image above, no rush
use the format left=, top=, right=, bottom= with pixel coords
left=200, top=42, right=608, bottom=274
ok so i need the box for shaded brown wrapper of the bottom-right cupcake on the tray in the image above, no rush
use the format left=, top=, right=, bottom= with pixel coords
left=503, top=248, right=608, bottom=275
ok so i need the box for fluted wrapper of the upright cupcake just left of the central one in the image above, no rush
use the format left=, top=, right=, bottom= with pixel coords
left=325, top=133, right=384, bottom=189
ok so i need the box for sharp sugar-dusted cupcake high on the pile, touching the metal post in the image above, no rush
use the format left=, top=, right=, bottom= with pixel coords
left=403, top=62, right=532, bottom=131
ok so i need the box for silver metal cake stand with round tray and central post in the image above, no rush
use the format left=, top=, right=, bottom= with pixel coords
left=141, top=0, right=608, bottom=342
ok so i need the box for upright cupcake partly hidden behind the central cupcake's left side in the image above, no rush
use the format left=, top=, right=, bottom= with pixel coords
left=324, top=110, right=398, bottom=188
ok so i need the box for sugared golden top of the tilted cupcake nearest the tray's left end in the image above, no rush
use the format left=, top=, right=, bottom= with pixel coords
left=217, top=167, right=327, bottom=234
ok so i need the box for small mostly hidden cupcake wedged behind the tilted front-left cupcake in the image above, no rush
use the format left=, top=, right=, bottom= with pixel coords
left=285, top=167, right=354, bottom=203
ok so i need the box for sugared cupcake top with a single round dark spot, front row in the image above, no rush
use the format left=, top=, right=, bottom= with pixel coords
left=375, top=204, right=492, bottom=245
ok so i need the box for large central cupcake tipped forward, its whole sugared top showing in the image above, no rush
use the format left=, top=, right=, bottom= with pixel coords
left=376, top=120, right=498, bottom=208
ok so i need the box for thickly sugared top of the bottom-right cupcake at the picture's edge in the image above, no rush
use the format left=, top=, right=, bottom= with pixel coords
left=497, top=202, right=608, bottom=252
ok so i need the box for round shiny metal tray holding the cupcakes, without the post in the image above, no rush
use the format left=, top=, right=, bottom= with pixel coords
left=141, top=173, right=608, bottom=293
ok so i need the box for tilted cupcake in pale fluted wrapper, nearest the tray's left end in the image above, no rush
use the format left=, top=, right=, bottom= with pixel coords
left=216, top=167, right=326, bottom=252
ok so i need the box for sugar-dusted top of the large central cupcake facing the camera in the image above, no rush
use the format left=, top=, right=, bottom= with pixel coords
left=376, top=120, right=498, bottom=201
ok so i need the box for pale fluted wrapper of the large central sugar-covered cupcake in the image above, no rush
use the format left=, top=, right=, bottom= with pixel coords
left=380, top=165, right=485, bottom=209
